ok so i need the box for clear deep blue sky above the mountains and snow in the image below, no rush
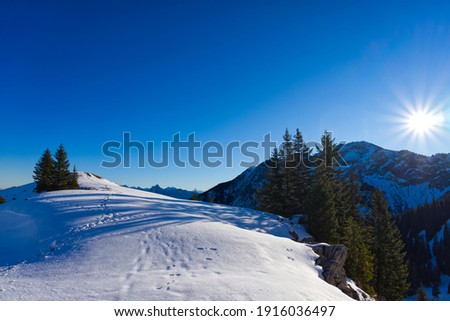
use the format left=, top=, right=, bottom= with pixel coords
left=0, top=0, right=450, bottom=190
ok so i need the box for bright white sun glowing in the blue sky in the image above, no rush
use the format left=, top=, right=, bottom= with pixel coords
left=405, top=110, right=444, bottom=136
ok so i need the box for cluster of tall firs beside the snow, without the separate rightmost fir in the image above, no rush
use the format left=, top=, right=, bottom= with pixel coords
left=256, top=129, right=374, bottom=294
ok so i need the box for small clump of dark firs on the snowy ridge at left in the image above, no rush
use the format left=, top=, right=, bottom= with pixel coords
left=33, top=144, right=80, bottom=193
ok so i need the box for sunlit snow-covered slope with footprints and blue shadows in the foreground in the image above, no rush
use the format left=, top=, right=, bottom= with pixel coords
left=0, top=173, right=350, bottom=300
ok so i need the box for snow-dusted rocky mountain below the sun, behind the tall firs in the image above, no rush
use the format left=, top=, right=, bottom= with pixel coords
left=200, top=142, right=450, bottom=214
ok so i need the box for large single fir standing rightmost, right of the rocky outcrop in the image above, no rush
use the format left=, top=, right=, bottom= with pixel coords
left=368, top=189, right=409, bottom=300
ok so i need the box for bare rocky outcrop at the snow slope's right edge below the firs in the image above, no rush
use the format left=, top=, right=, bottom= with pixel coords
left=310, top=243, right=359, bottom=300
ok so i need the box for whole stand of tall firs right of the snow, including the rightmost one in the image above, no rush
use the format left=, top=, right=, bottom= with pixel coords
left=256, top=129, right=409, bottom=300
